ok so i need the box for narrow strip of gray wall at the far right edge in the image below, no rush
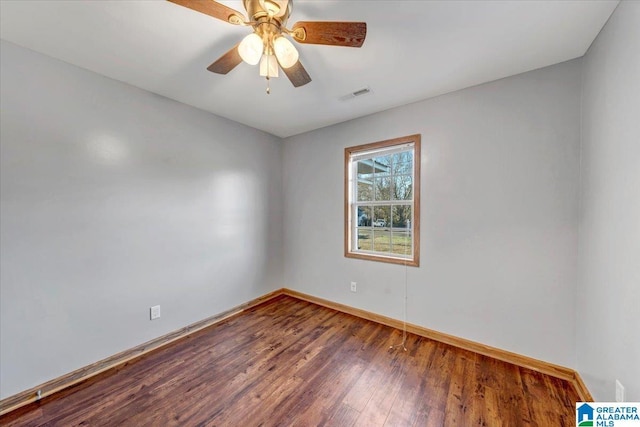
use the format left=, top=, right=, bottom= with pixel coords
left=577, top=1, right=640, bottom=402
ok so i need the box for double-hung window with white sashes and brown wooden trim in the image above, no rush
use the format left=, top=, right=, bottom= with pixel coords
left=344, top=135, right=420, bottom=266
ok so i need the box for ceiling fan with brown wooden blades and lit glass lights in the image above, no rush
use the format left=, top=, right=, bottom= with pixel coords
left=168, top=0, right=367, bottom=93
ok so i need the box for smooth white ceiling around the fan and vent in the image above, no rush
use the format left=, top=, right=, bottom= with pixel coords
left=0, top=0, right=618, bottom=137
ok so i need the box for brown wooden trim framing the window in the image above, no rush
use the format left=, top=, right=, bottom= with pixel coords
left=344, top=134, right=421, bottom=267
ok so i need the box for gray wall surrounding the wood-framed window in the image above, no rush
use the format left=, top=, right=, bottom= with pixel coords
left=283, top=60, right=581, bottom=366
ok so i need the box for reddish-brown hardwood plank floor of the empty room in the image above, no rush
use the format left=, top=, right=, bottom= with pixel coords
left=0, top=296, right=579, bottom=427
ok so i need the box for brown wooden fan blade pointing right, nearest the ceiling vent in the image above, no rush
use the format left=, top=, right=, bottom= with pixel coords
left=292, top=21, right=367, bottom=47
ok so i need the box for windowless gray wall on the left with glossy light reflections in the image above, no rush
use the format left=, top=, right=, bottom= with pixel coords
left=0, top=42, right=282, bottom=397
